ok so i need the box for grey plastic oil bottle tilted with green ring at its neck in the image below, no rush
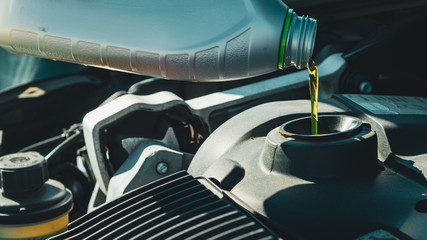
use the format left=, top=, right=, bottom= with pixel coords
left=0, top=0, right=317, bottom=81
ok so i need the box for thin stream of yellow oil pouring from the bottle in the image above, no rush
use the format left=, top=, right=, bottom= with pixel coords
left=308, top=58, right=319, bottom=135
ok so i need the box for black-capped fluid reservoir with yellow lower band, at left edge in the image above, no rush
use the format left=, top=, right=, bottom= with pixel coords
left=0, top=152, right=73, bottom=239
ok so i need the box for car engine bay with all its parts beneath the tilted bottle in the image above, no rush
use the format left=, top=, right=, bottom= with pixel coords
left=0, top=1, right=427, bottom=239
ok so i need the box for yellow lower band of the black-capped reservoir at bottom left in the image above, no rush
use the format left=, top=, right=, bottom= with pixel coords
left=0, top=212, right=68, bottom=239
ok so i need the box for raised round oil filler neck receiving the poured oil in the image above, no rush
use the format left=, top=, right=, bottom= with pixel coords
left=261, top=115, right=378, bottom=181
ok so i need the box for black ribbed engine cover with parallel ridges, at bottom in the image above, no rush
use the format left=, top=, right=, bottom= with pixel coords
left=51, top=171, right=278, bottom=239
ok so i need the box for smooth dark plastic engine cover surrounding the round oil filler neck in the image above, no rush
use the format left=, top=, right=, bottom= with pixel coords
left=188, top=95, right=427, bottom=239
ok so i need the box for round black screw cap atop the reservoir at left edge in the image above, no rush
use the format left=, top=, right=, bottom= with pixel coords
left=0, top=152, right=49, bottom=194
